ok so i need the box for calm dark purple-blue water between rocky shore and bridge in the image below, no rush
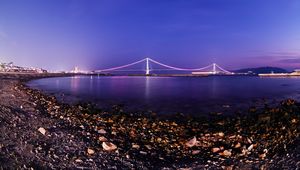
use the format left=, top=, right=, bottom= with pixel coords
left=29, top=76, right=300, bottom=115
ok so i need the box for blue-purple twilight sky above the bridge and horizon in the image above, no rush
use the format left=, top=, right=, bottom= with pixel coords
left=0, top=0, right=300, bottom=70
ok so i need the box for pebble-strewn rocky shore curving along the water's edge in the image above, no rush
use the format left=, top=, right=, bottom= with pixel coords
left=0, top=77, right=300, bottom=169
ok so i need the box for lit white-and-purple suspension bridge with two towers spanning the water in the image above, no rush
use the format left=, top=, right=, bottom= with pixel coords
left=95, top=58, right=234, bottom=75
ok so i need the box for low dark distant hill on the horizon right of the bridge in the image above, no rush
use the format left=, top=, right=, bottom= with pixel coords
left=234, top=67, right=288, bottom=74
